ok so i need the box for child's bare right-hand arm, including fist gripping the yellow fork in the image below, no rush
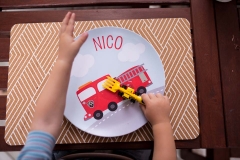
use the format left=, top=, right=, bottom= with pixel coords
left=141, top=93, right=177, bottom=160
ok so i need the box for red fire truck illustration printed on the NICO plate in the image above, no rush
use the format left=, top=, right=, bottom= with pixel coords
left=76, top=64, right=152, bottom=121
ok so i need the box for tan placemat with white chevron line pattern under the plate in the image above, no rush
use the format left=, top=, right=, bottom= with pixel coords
left=5, top=18, right=199, bottom=145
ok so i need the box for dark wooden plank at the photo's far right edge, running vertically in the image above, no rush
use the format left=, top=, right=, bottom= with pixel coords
left=215, top=0, right=240, bottom=148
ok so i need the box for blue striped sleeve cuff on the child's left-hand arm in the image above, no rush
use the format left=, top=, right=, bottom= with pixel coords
left=17, top=131, right=56, bottom=160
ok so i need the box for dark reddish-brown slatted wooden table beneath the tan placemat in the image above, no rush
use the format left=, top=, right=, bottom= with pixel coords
left=0, top=0, right=232, bottom=151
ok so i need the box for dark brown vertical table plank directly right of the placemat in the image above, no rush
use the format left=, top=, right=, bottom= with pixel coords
left=191, top=0, right=226, bottom=148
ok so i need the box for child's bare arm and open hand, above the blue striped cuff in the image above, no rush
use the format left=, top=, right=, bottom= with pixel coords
left=31, top=12, right=88, bottom=139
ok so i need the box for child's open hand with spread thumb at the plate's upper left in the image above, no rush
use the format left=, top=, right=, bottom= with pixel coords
left=58, top=12, right=88, bottom=64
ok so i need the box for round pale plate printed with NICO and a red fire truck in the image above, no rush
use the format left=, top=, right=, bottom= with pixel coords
left=64, top=27, right=165, bottom=137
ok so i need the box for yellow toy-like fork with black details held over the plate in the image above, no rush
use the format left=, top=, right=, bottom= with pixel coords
left=103, top=76, right=144, bottom=104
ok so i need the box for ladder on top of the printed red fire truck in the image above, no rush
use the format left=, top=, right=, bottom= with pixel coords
left=117, top=64, right=147, bottom=84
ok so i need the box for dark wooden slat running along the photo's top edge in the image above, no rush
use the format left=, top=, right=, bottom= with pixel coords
left=0, top=0, right=190, bottom=9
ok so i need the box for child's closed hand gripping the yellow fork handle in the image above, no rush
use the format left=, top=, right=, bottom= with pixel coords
left=141, top=93, right=171, bottom=126
